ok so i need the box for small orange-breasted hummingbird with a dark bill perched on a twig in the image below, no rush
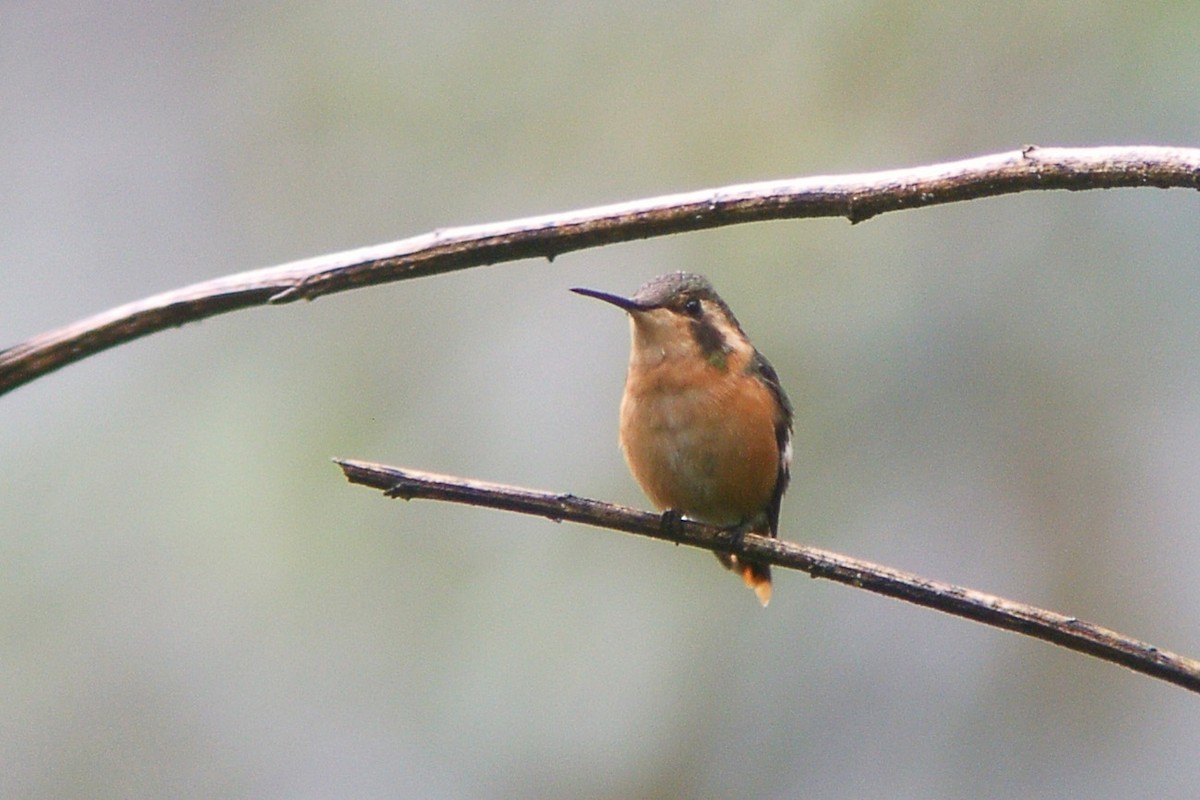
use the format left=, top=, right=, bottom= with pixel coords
left=571, top=272, right=792, bottom=606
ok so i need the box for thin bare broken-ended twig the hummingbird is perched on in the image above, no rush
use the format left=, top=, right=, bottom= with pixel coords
left=335, top=459, right=1200, bottom=692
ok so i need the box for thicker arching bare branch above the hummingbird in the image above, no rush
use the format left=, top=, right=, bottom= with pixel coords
left=0, top=146, right=1200, bottom=395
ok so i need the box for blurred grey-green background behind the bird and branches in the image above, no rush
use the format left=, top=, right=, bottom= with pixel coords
left=0, top=2, right=1200, bottom=799
